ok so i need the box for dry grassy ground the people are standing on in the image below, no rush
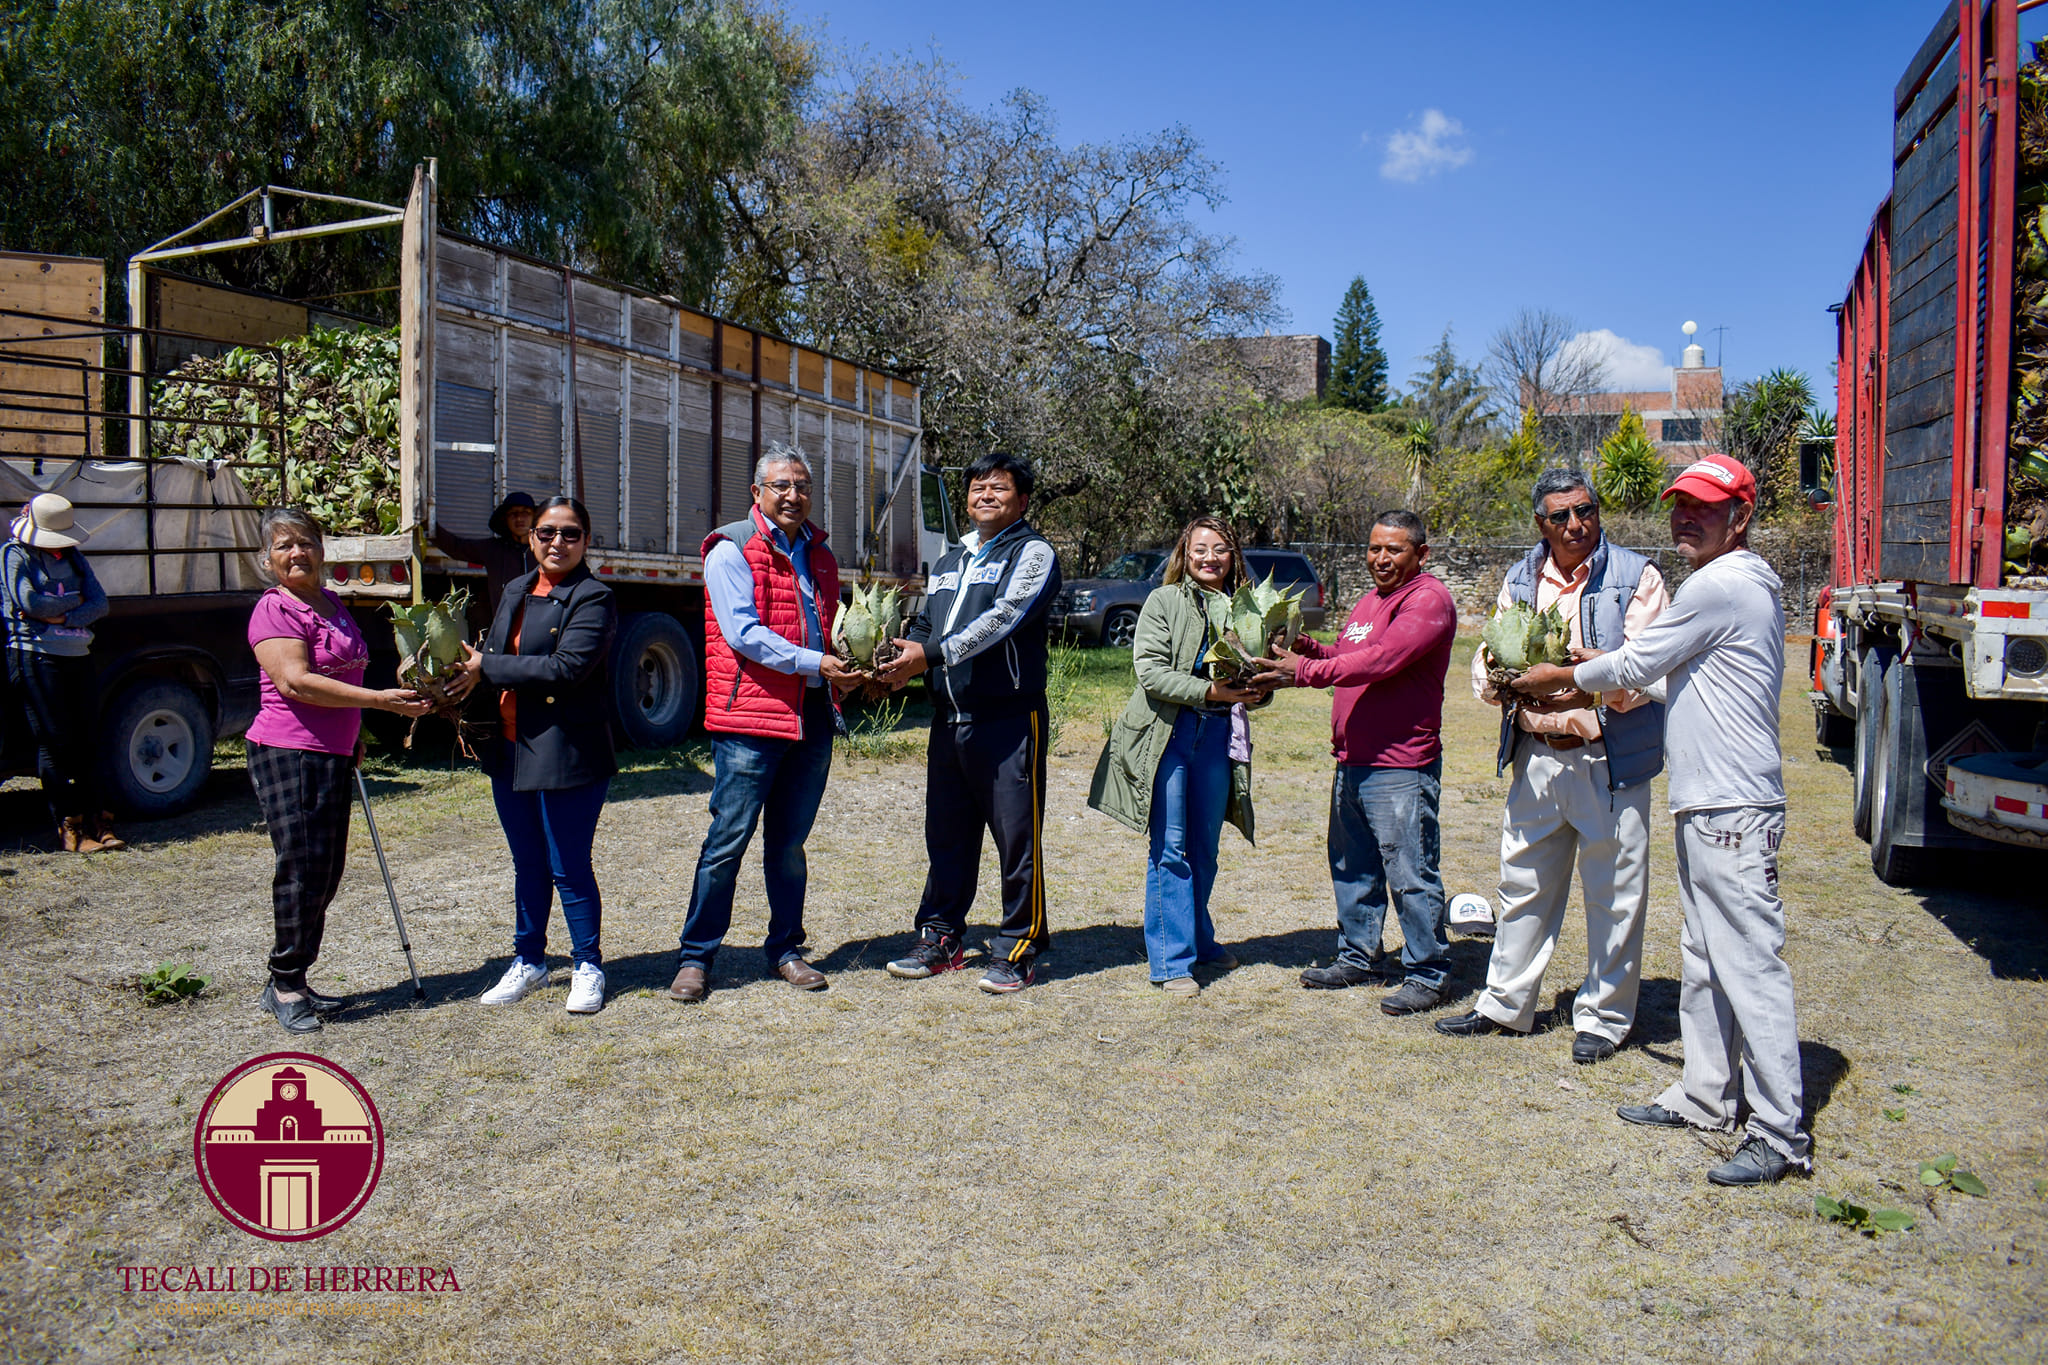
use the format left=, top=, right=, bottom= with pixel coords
left=0, top=645, right=2048, bottom=1361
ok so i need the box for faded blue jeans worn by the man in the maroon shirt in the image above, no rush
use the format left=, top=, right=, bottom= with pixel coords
left=1329, top=759, right=1450, bottom=990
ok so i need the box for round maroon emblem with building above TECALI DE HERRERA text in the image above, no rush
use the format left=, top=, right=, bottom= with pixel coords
left=193, top=1052, right=383, bottom=1242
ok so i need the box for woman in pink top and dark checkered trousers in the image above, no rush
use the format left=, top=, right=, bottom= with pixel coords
left=248, top=508, right=432, bottom=1033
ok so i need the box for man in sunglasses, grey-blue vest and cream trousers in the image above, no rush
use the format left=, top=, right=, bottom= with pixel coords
left=1436, top=467, right=1671, bottom=1066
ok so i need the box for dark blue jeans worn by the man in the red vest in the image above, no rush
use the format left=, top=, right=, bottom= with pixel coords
left=680, top=688, right=834, bottom=972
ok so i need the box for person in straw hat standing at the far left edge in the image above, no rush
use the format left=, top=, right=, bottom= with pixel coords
left=0, top=493, right=127, bottom=853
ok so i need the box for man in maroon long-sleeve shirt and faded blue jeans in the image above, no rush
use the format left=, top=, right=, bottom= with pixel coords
left=1268, top=512, right=1458, bottom=1015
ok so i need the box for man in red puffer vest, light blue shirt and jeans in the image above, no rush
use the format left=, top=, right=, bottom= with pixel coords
left=668, top=444, right=860, bottom=1001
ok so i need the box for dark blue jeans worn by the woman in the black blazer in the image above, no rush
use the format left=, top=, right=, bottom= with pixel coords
left=492, top=772, right=612, bottom=966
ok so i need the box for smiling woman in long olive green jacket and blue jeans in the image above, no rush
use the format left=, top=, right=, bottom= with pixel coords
left=1087, top=516, right=1266, bottom=997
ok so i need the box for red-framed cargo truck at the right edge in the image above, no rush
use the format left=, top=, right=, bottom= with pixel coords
left=1812, top=0, right=2048, bottom=884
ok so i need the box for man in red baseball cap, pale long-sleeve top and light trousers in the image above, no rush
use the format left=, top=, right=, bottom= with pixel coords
left=1516, top=454, right=1812, bottom=1185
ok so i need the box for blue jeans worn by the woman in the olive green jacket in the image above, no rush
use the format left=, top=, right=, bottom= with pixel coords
left=1145, top=706, right=1231, bottom=982
